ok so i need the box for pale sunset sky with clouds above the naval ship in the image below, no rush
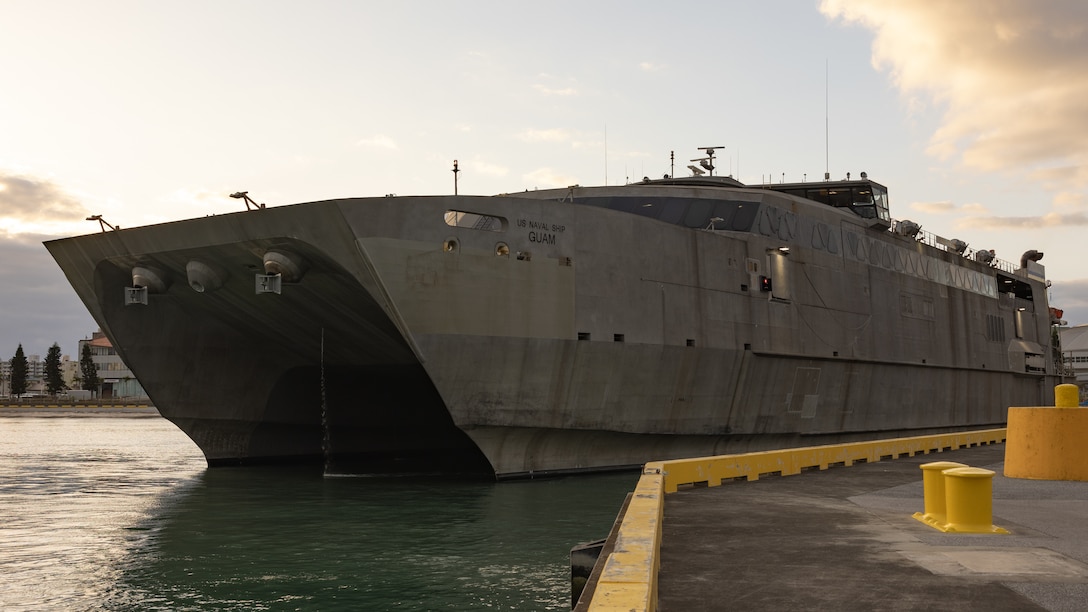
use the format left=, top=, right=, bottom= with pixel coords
left=0, top=0, right=1088, bottom=358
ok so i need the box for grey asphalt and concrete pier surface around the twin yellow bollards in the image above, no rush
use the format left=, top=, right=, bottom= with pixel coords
left=652, top=444, right=1088, bottom=612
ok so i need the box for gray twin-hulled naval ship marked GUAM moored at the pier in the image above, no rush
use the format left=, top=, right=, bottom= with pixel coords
left=46, top=150, right=1056, bottom=478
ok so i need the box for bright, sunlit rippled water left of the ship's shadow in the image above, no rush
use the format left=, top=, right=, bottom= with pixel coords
left=0, top=417, right=203, bottom=610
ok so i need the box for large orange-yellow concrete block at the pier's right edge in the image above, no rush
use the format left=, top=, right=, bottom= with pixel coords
left=1004, top=407, right=1088, bottom=482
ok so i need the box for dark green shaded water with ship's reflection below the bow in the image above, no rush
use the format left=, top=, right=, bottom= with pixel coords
left=109, top=468, right=635, bottom=610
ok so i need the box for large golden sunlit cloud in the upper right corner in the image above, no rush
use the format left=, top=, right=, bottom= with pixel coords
left=820, top=0, right=1088, bottom=198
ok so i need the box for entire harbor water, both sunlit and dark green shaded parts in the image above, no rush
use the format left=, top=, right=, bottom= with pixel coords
left=0, top=417, right=638, bottom=610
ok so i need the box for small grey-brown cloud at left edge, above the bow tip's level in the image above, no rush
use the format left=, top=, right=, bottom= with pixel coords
left=0, top=173, right=89, bottom=236
